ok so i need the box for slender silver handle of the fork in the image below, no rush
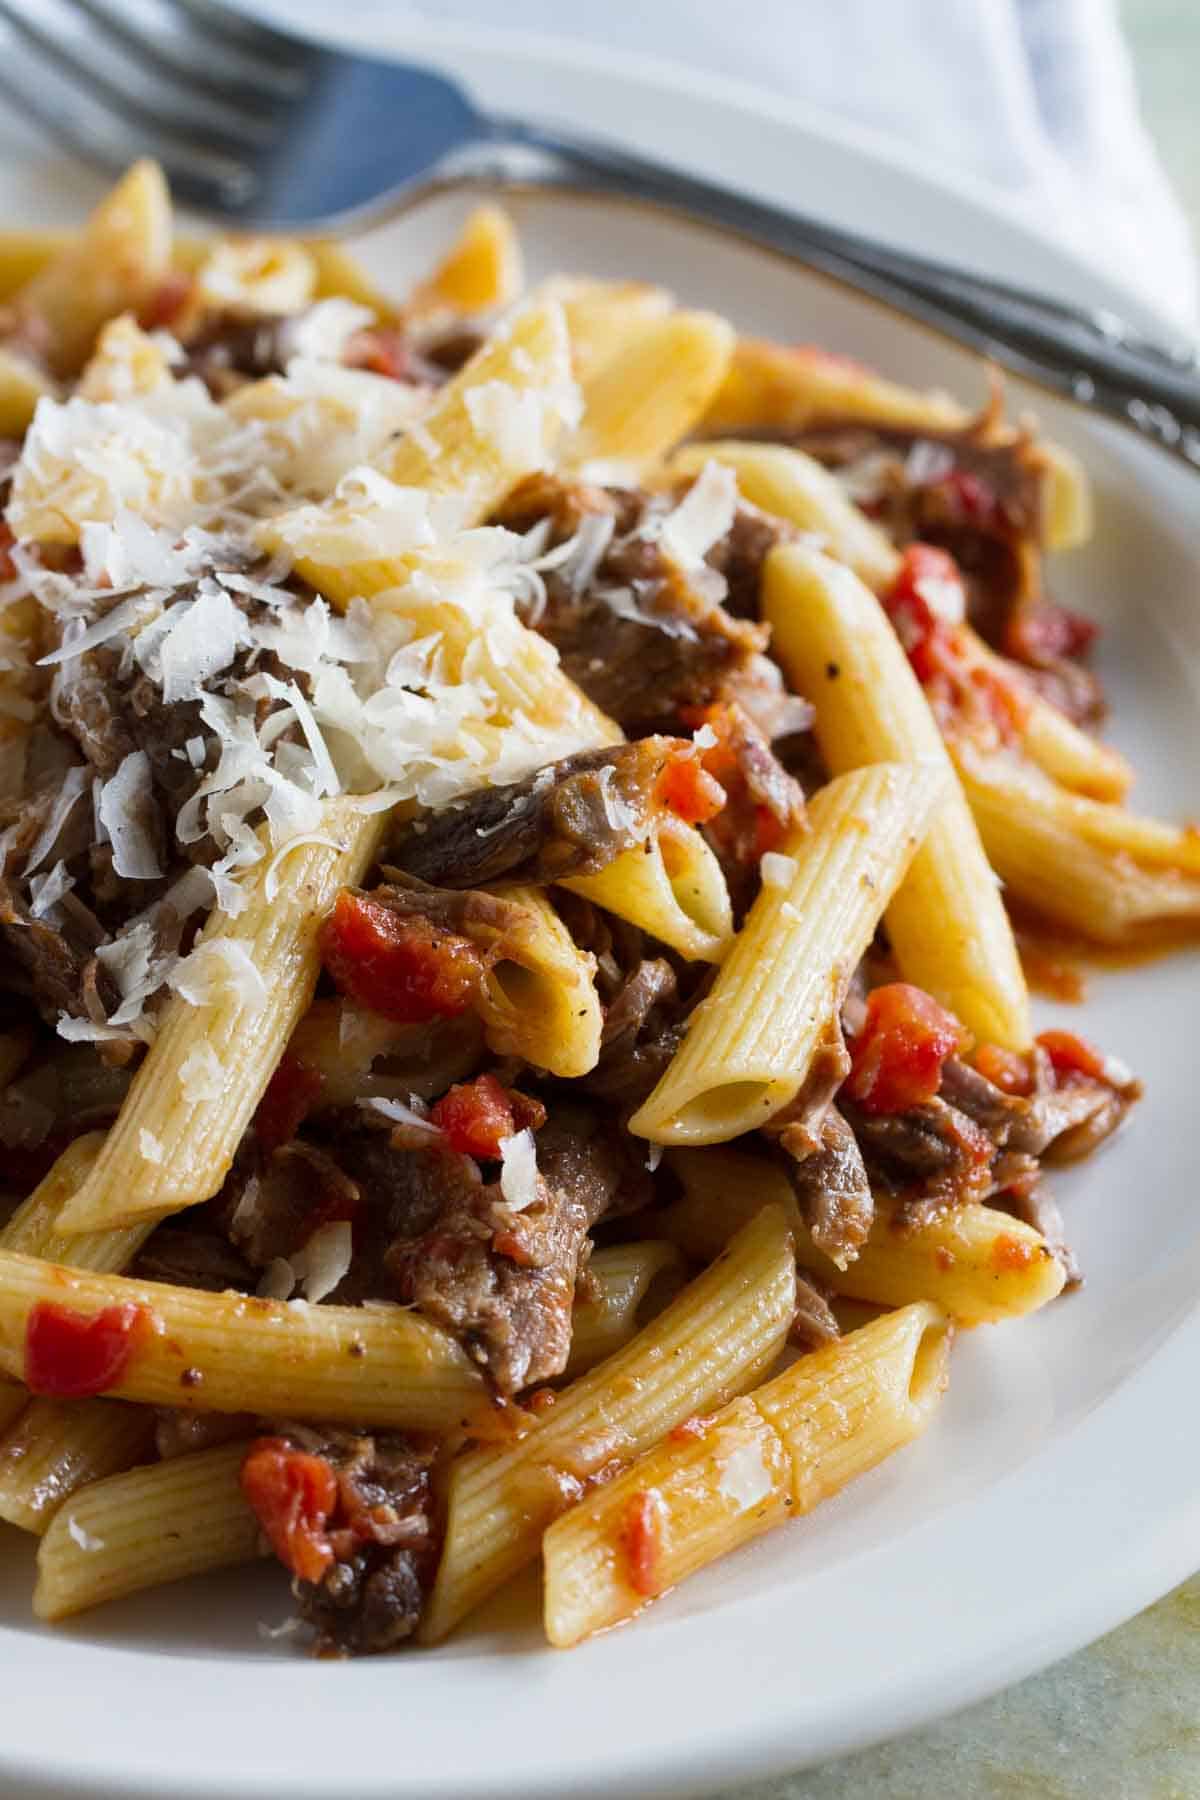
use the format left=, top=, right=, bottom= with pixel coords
left=493, top=121, right=1200, bottom=470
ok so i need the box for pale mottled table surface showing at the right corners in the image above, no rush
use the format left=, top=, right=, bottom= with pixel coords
left=723, top=0, right=1200, bottom=1800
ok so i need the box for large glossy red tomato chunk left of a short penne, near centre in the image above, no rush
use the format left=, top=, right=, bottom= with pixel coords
left=320, top=887, right=484, bottom=1024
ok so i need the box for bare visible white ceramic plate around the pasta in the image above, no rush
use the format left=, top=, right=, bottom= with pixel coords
left=0, top=17, right=1200, bottom=1800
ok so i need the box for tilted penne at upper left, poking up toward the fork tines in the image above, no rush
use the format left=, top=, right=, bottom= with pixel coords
left=14, top=160, right=171, bottom=376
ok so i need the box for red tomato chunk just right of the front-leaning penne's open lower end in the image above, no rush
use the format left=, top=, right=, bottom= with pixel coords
left=846, top=981, right=963, bottom=1112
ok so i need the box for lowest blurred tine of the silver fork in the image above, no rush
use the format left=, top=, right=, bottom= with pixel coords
left=0, top=41, right=257, bottom=212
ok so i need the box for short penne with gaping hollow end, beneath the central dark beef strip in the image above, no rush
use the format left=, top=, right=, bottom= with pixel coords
left=561, top=819, right=734, bottom=963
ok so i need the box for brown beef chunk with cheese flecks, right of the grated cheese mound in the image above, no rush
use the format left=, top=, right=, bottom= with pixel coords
left=497, top=475, right=765, bottom=731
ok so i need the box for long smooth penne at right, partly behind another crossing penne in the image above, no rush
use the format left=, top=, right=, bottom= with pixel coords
left=763, top=544, right=1031, bottom=1049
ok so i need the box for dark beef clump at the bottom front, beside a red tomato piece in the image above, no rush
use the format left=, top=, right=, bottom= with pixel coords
left=268, top=1424, right=439, bottom=1656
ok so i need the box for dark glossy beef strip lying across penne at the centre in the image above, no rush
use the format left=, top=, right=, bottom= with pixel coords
left=389, top=738, right=687, bottom=887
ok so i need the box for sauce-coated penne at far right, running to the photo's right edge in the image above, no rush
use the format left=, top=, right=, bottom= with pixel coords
left=955, top=745, right=1200, bottom=945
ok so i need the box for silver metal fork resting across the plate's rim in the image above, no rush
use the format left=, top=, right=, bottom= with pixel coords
left=0, top=0, right=1200, bottom=468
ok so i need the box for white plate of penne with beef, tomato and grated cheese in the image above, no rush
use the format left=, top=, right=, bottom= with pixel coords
left=0, top=17, right=1200, bottom=1796
